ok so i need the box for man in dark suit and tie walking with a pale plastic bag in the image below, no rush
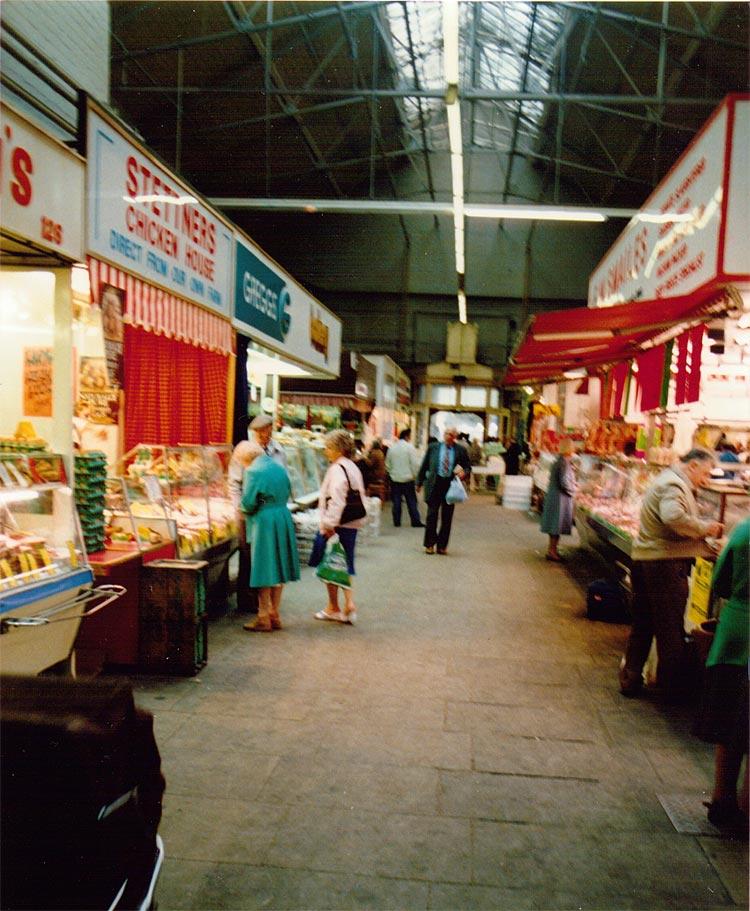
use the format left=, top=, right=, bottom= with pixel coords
left=416, top=427, right=471, bottom=554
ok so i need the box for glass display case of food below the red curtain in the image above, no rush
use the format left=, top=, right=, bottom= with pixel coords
left=123, top=444, right=237, bottom=558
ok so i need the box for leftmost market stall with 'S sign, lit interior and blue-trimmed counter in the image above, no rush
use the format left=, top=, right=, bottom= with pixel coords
left=0, top=104, right=122, bottom=674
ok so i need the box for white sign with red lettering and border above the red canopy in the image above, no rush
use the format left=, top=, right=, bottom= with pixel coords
left=588, top=96, right=750, bottom=307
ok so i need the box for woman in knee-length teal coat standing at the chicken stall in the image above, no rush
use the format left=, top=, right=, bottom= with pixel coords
left=240, top=443, right=299, bottom=633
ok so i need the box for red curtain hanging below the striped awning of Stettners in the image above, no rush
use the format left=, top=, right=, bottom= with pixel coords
left=124, top=325, right=229, bottom=450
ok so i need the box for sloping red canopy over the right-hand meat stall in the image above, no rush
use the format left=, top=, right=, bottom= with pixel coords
left=503, top=289, right=728, bottom=386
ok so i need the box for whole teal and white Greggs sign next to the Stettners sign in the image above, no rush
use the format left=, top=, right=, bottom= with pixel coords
left=233, top=234, right=341, bottom=377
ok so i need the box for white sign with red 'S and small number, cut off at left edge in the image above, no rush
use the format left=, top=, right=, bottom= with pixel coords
left=0, top=104, right=84, bottom=260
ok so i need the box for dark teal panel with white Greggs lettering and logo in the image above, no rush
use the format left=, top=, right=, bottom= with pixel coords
left=234, top=244, right=291, bottom=342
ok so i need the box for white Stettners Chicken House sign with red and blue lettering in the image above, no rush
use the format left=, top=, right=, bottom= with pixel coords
left=87, top=108, right=232, bottom=316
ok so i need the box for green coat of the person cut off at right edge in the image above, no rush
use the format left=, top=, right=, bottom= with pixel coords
left=706, top=518, right=750, bottom=667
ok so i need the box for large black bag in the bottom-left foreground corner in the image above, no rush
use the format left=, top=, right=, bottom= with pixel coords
left=0, top=676, right=164, bottom=911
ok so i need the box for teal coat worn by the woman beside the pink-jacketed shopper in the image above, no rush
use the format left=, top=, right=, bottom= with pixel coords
left=240, top=455, right=299, bottom=588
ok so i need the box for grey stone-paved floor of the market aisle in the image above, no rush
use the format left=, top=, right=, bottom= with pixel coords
left=136, top=496, right=747, bottom=911
